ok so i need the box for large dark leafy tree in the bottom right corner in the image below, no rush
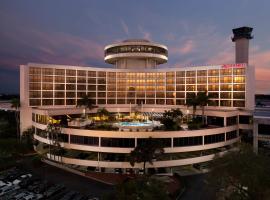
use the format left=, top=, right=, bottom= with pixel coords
left=208, top=145, right=270, bottom=200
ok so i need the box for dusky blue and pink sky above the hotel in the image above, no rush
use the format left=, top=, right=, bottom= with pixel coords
left=0, top=0, right=270, bottom=94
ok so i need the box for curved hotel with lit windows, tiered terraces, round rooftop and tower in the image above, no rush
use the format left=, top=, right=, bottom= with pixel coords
left=20, top=27, right=254, bottom=172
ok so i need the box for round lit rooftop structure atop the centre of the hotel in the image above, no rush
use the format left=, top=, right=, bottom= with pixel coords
left=104, top=39, right=168, bottom=68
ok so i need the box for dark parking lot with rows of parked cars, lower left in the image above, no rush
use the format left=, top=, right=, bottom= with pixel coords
left=0, top=164, right=113, bottom=200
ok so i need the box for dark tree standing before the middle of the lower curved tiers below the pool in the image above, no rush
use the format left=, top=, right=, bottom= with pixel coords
left=130, top=137, right=164, bottom=174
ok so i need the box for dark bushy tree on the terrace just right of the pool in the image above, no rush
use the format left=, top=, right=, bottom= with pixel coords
left=161, top=108, right=183, bottom=130
